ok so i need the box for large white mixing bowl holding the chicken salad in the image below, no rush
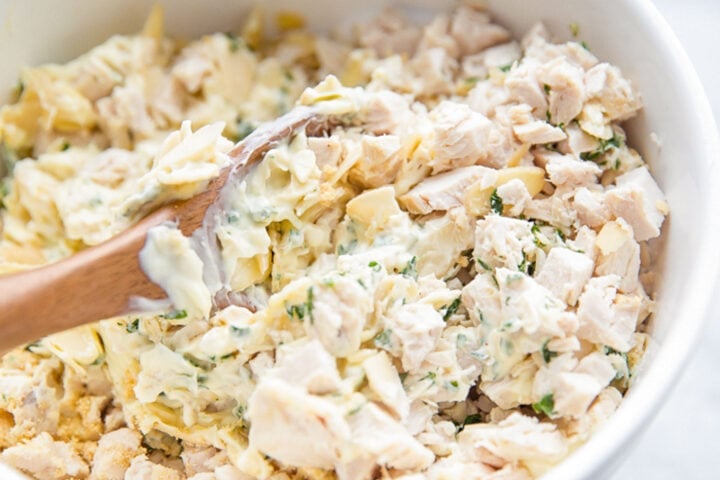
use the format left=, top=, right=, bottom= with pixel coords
left=0, top=0, right=720, bottom=479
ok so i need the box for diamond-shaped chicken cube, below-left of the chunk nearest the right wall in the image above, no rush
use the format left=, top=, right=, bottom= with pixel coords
left=536, top=247, right=594, bottom=305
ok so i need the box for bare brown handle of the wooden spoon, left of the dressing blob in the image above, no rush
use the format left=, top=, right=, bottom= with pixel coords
left=0, top=206, right=177, bottom=352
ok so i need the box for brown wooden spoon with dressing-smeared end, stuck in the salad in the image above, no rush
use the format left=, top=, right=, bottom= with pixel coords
left=0, top=107, right=319, bottom=352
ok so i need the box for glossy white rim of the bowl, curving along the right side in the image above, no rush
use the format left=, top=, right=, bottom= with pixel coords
left=541, top=0, right=720, bottom=480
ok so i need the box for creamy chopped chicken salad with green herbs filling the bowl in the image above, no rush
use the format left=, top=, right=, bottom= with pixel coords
left=0, top=5, right=668, bottom=480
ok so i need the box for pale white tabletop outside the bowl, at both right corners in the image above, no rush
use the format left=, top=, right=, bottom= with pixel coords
left=612, top=0, right=720, bottom=480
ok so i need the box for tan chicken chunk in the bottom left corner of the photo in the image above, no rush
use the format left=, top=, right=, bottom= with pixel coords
left=0, top=432, right=89, bottom=480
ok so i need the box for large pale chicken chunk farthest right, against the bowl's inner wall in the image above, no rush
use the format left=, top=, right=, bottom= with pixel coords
left=605, top=167, right=668, bottom=242
